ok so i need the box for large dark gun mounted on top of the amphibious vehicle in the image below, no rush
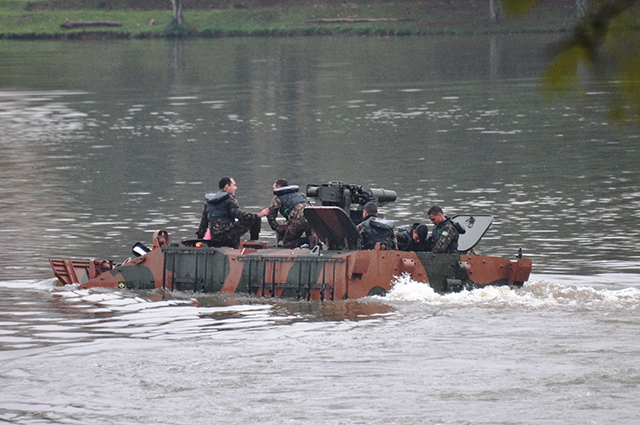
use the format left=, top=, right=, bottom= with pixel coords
left=307, top=182, right=398, bottom=224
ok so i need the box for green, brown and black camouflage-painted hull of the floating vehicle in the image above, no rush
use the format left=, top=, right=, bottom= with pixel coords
left=50, top=242, right=532, bottom=301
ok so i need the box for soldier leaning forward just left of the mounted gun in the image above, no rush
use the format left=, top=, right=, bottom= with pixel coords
left=267, top=179, right=313, bottom=248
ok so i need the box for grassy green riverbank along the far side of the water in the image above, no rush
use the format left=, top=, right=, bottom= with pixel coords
left=0, top=0, right=576, bottom=39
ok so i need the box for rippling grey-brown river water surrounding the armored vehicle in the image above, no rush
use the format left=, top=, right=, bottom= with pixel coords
left=0, top=35, right=640, bottom=424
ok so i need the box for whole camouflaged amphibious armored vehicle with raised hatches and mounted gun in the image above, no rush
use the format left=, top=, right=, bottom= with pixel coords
left=49, top=182, right=532, bottom=301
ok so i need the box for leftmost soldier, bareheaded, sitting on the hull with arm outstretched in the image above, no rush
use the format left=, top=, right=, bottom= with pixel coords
left=196, top=176, right=269, bottom=248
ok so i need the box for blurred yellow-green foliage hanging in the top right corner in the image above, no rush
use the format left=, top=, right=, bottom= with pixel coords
left=503, top=0, right=640, bottom=124
